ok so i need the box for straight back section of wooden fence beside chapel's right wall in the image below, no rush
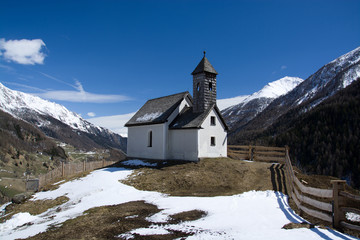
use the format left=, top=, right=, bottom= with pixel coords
left=228, top=145, right=286, bottom=163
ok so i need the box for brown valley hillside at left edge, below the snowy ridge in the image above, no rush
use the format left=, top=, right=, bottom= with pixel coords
left=0, top=107, right=125, bottom=204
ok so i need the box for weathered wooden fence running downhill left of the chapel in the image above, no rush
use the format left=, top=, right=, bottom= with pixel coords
left=26, top=161, right=115, bottom=191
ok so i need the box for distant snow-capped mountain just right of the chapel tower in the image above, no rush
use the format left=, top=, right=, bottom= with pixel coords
left=218, top=77, right=304, bottom=129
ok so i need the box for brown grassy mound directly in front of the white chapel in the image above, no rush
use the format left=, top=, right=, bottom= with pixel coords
left=123, top=158, right=273, bottom=197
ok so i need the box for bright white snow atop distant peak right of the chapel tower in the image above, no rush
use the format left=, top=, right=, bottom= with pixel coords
left=217, top=76, right=304, bottom=110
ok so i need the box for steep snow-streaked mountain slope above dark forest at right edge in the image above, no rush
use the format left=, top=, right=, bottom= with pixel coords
left=229, top=47, right=360, bottom=143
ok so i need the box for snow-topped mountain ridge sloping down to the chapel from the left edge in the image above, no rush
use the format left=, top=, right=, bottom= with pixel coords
left=0, top=83, right=126, bottom=151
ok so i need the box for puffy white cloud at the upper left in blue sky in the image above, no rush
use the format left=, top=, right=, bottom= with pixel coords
left=0, top=38, right=46, bottom=65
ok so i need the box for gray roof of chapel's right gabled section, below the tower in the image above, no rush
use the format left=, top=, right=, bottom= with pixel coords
left=169, top=104, right=228, bottom=130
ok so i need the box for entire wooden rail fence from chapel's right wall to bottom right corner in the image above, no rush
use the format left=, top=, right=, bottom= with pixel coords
left=228, top=145, right=360, bottom=231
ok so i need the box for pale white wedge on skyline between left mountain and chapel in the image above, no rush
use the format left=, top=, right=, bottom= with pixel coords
left=86, top=112, right=135, bottom=137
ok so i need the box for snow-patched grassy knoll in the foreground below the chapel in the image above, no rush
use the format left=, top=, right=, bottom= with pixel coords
left=0, top=159, right=356, bottom=240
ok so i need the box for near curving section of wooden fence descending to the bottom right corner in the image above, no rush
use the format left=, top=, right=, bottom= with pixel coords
left=285, top=149, right=360, bottom=231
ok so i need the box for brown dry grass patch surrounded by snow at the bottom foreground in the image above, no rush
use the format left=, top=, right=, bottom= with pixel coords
left=28, top=201, right=205, bottom=240
